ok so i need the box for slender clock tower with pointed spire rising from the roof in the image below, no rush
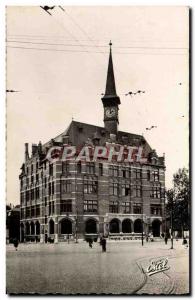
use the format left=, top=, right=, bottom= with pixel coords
left=102, top=41, right=120, bottom=134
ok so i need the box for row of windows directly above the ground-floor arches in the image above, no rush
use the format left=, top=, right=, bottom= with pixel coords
left=21, top=200, right=162, bottom=219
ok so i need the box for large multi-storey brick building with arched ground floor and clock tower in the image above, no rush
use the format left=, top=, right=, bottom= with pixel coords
left=19, top=45, right=165, bottom=242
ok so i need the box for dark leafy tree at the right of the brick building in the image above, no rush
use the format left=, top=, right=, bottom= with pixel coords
left=166, top=168, right=190, bottom=237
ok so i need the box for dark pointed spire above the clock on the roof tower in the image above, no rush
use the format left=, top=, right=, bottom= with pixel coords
left=105, top=41, right=116, bottom=96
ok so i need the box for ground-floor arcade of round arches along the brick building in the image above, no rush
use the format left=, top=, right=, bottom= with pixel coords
left=20, top=214, right=163, bottom=242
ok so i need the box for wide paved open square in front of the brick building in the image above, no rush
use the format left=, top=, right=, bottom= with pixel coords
left=6, top=240, right=189, bottom=294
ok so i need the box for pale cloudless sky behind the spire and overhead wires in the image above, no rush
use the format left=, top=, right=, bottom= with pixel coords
left=6, top=6, right=189, bottom=204
